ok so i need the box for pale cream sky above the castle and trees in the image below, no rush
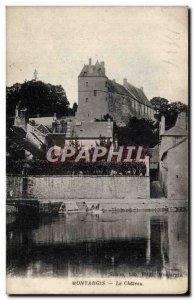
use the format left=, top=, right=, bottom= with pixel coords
left=6, top=6, right=188, bottom=104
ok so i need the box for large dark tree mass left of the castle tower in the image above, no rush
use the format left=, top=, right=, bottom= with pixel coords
left=6, top=80, right=69, bottom=116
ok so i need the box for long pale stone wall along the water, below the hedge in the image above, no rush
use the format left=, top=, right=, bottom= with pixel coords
left=7, top=175, right=150, bottom=203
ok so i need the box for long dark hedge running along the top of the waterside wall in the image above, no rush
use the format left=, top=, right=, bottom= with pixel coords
left=7, top=159, right=146, bottom=176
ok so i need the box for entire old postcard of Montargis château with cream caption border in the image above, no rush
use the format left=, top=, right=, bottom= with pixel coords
left=6, top=6, right=189, bottom=295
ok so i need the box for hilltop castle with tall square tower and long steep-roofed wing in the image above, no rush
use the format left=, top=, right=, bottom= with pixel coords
left=76, top=58, right=154, bottom=126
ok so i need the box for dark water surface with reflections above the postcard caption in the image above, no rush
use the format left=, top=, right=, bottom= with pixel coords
left=7, top=212, right=187, bottom=277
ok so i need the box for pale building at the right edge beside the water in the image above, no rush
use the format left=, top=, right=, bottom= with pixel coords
left=159, top=113, right=188, bottom=200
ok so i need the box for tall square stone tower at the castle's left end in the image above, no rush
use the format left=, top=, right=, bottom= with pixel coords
left=76, top=58, right=108, bottom=121
